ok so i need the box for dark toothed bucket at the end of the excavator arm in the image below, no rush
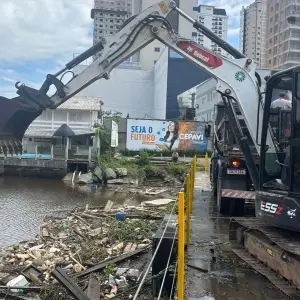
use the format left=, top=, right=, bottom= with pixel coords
left=0, top=96, right=43, bottom=156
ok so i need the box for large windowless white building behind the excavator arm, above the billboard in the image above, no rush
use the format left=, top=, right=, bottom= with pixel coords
left=73, top=49, right=168, bottom=119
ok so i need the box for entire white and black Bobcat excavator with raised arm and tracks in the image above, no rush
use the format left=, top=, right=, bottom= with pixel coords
left=0, top=0, right=300, bottom=299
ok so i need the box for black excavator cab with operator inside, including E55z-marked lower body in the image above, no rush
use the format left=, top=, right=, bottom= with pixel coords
left=256, top=67, right=300, bottom=231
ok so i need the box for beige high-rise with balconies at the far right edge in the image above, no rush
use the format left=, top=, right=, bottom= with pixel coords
left=266, top=0, right=300, bottom=69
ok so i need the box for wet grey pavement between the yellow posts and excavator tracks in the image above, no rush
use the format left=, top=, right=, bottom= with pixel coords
left=185, top=173, right=289, bottom=300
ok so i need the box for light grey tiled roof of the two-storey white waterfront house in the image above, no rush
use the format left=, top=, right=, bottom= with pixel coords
left=58, top=96, right=101, bottom=111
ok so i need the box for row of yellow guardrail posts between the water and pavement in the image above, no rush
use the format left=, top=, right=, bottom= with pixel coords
left=177, top=155, right=198, bottom=300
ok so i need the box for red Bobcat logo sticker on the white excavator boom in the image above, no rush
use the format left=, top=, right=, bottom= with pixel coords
left=177, top=41, right=223, bottom=69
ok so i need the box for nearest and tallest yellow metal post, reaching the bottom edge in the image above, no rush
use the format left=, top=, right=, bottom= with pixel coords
left=177, top=192, right=184, bottom=300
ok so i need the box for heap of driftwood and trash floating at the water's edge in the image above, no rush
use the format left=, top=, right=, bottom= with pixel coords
left=0, top=199, right=174, bottom=300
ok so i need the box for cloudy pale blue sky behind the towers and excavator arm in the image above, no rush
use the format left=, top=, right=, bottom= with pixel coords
left=0, top=0, right=254, bottom=98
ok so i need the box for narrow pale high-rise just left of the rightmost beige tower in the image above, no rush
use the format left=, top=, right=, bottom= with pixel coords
left=240, top=0, right=267, bottom=68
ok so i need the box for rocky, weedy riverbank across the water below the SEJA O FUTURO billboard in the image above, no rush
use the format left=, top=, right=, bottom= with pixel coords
left=74, top=151, right=189, bottom=189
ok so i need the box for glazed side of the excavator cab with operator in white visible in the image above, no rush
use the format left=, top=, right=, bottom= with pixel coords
left=260, top=70, right=292, bottom=191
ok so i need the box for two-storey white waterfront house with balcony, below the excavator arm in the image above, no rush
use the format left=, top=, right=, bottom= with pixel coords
left=23, top=97, right=101, bottom=160
